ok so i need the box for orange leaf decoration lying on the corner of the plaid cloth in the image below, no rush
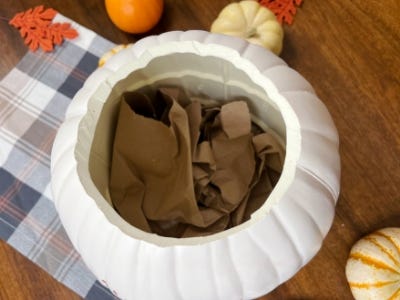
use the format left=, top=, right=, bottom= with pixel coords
left=9, top=5, right=78, bottom=52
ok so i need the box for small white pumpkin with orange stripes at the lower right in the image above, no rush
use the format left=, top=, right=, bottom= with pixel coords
left=346, top=227, right=400, bottom=300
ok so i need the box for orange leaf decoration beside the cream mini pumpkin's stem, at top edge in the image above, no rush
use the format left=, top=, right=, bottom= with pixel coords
left=259, top=0, right=303, bottom=25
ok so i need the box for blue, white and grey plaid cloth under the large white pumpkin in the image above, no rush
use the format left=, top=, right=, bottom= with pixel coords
left=0, top=15, right=119, bottom=300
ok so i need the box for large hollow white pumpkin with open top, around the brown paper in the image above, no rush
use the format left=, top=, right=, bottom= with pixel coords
left=51, top=31, right=340, bottom=299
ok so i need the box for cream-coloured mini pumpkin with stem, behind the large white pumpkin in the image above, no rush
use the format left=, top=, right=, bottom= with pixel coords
left=210, top=0, right=283, bottom=55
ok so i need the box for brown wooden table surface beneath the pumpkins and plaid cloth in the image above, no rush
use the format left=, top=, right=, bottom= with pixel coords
left=0, top=0, right=400, bottom=300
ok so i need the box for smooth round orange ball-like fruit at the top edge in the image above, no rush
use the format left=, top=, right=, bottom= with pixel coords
left=105, top=0, right=164, bottom=33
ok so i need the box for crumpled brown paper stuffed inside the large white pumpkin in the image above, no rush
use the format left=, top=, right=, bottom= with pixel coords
left=110, top=88, right=284, bottom=237
